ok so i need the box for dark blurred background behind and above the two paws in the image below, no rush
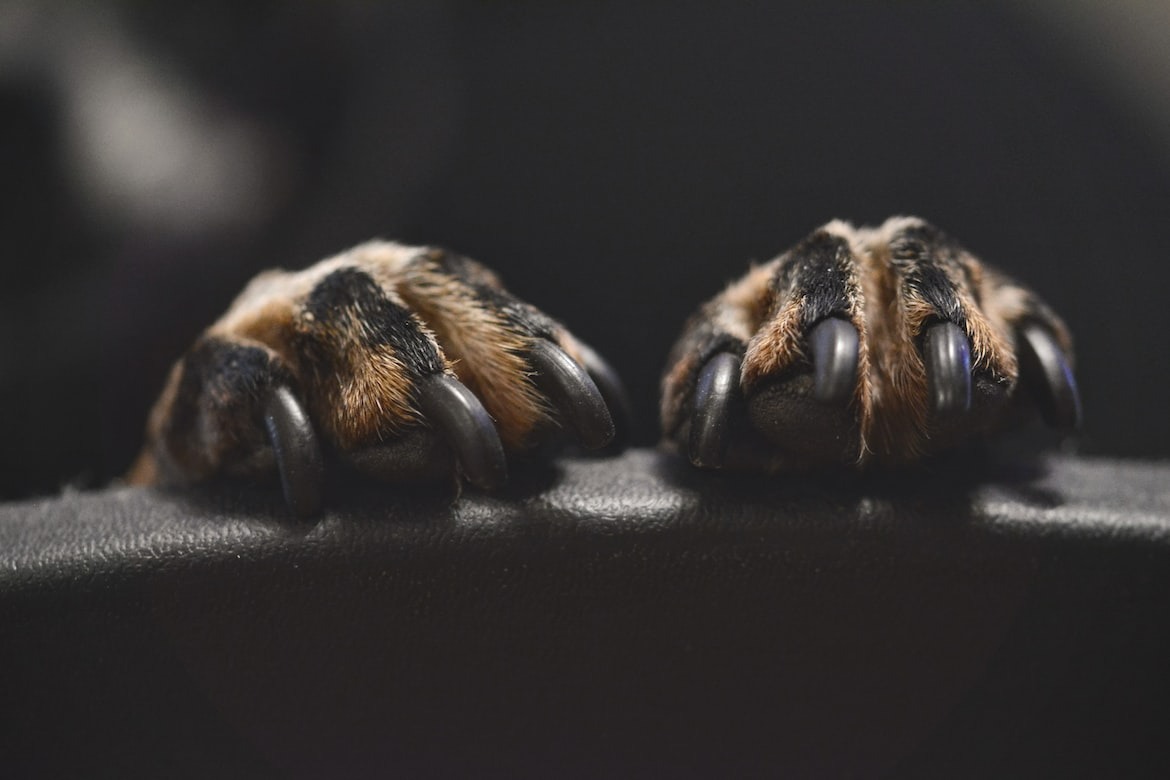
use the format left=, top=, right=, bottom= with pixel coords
left=0, top=0, right=1170, bottom=498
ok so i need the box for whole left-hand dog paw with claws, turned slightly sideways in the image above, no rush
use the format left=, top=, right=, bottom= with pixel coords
left=129, top=242, right=626, bottom=515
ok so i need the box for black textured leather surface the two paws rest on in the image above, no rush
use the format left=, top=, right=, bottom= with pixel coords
left=0, top=450, right=1170, bottom=778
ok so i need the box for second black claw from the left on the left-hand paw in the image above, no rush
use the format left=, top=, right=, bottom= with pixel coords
left=415, top=374, right=508, bottom=490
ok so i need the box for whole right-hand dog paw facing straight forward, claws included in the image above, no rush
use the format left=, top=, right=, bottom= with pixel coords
left=661, top=218, right=1081, bottom=471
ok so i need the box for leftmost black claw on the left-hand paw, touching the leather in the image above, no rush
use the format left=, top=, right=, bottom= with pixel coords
left=264, top=385, right=324, bottom=517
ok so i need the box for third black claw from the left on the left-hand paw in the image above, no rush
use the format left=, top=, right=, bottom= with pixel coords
left=528, top=339, right=614, bottom=449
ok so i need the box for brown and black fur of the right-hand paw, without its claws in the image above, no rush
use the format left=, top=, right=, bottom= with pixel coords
left=661, top=218, right=1072, bottom=471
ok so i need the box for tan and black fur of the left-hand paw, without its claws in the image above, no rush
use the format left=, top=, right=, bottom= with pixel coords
left=128, top=241, right=603, bottom=484
